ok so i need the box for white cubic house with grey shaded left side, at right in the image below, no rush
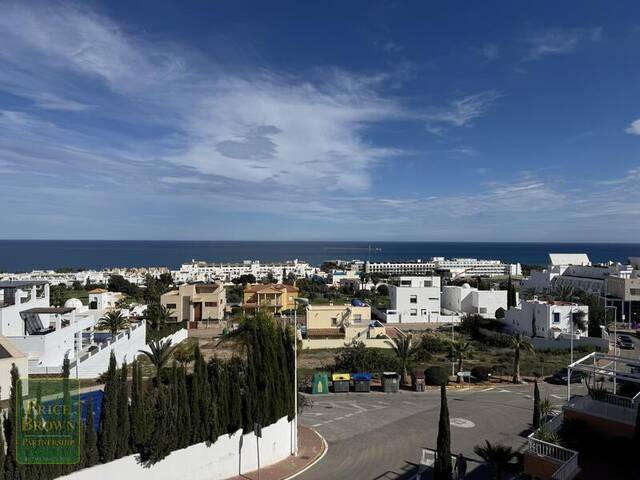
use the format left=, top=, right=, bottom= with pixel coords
left=502, top=299, right=589, bottom=339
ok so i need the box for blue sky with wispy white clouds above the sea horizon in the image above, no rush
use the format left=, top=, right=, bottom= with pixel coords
left=0, top=0, right=640, bottom=242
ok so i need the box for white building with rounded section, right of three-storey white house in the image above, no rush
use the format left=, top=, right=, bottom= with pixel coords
left=442, top=283, right=507, bottom=319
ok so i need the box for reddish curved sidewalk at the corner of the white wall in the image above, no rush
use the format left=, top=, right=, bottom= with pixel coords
left=228, top=425, right=327, bottom=480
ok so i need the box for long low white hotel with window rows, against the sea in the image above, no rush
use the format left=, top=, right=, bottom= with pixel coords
left=365, top=257, right=522, bottom=277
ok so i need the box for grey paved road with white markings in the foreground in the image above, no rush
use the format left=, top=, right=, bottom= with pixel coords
left=298, top=383, right=584, bottom=480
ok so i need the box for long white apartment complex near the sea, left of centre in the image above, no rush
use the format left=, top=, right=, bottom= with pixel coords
left=171, top=259, right=320, bottom=283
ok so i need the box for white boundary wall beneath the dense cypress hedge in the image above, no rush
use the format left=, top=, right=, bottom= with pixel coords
left=60, top=417, right=295, bottom=480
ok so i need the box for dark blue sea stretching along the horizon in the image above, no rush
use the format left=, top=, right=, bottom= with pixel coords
left=0, top=240, right=640, bottom=272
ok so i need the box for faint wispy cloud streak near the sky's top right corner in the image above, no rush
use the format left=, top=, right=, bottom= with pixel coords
left=522, top=27, right=602, bottom=61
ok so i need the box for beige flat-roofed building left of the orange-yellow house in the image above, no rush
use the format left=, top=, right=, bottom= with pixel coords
left=160, top=283, right=227, bottom=326
